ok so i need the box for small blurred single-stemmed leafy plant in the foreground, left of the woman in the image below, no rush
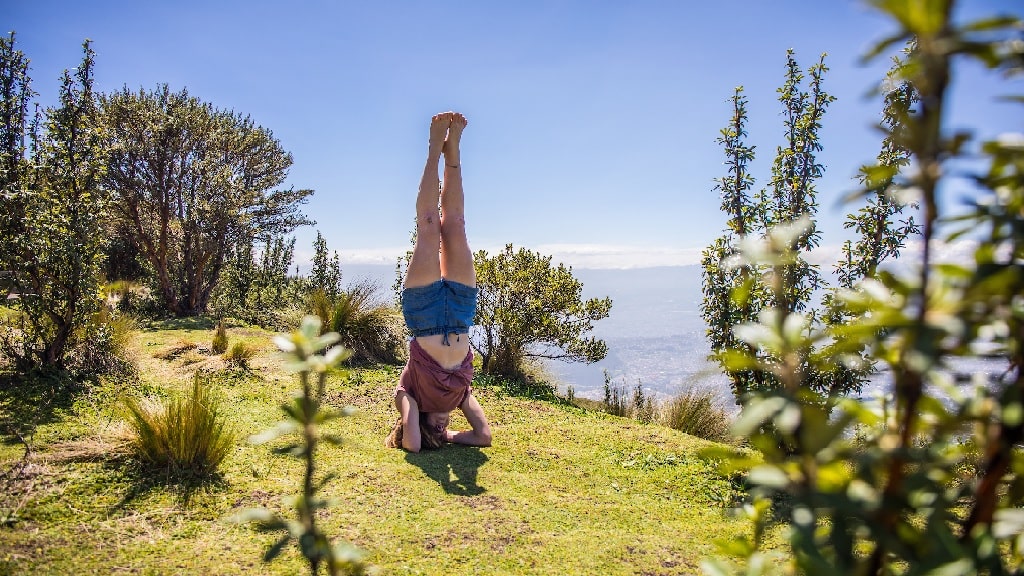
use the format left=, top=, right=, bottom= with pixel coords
left=238, top=316, right=368, bottom=576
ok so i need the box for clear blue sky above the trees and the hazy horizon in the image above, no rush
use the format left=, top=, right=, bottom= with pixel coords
left=8, top=0, right=1024, bottom=268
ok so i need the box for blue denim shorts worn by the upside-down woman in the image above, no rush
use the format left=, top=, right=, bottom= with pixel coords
left=401, top=278, right=477, bottom=339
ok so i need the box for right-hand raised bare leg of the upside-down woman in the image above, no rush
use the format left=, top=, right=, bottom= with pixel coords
left=439, top=112, right=476, bottom=286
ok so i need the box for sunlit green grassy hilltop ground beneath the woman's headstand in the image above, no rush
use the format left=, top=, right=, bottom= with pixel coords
left=0, top=315, right=749, bottom=574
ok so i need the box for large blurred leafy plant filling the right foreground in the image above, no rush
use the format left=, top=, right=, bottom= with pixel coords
left=705, top=0, right=1024, bottom=575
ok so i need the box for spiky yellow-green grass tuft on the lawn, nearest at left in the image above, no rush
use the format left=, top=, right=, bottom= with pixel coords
left=124, top=372, right=236, bottom=477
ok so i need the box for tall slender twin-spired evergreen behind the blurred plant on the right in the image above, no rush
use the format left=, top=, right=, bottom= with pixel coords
left=701, top=50, right=853, bottom=402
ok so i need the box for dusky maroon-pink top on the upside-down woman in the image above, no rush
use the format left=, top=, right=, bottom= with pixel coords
left=396, top=339, right=473, bottom=412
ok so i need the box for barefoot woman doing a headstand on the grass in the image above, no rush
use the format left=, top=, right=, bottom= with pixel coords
left=386, top=112, right=490, bottom=452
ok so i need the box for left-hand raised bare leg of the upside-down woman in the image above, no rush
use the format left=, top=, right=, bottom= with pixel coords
left=406, top=112, right=452, bottom=288
